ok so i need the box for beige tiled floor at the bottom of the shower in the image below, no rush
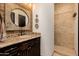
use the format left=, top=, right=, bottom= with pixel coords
left=53, top=46, right=76, bottom=56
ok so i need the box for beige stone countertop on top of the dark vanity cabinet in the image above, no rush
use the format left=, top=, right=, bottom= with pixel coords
left=0, top=33, right=41, bottom=48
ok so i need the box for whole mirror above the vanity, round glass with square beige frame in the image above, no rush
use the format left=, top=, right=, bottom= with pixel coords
left=5, top=3, right=32, bottom=31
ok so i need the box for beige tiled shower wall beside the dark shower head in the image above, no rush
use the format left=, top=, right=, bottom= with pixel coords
left=54, top=4, right=75, bottom=48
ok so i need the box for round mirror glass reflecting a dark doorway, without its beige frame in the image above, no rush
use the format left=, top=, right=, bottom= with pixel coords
left=10, top=9, right=29, bottom=27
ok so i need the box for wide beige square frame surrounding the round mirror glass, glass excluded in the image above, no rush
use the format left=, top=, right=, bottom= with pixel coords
left=5, top=3, right=32, bottom=31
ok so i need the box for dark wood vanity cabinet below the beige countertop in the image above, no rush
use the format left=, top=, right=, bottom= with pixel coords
left=0, top=37, right=40, bottom=56
